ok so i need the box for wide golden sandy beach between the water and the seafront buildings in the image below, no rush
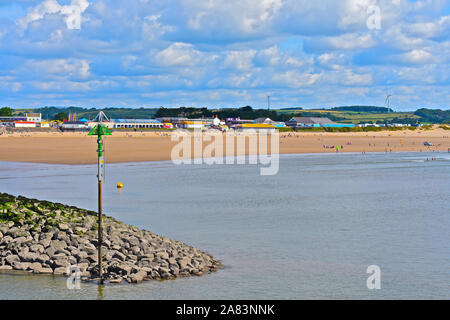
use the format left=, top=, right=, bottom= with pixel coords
left=0, top=129, right=450, bottom=164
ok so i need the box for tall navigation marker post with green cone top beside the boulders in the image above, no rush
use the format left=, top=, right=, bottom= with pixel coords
left=88, top=112, right=111, bottom=284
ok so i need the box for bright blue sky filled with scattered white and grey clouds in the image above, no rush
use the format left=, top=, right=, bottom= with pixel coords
left=0, top=0, right=450, bottom=111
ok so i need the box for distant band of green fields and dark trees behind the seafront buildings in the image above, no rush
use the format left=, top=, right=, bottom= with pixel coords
left=3, top=106, right=450, bottom=124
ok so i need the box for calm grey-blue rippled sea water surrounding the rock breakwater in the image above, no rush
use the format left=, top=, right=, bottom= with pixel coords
left=0, top=153, right=450, bottom=299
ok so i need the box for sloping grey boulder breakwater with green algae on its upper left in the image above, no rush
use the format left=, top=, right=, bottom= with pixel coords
left=0, top=193, right=221, bottom=283
